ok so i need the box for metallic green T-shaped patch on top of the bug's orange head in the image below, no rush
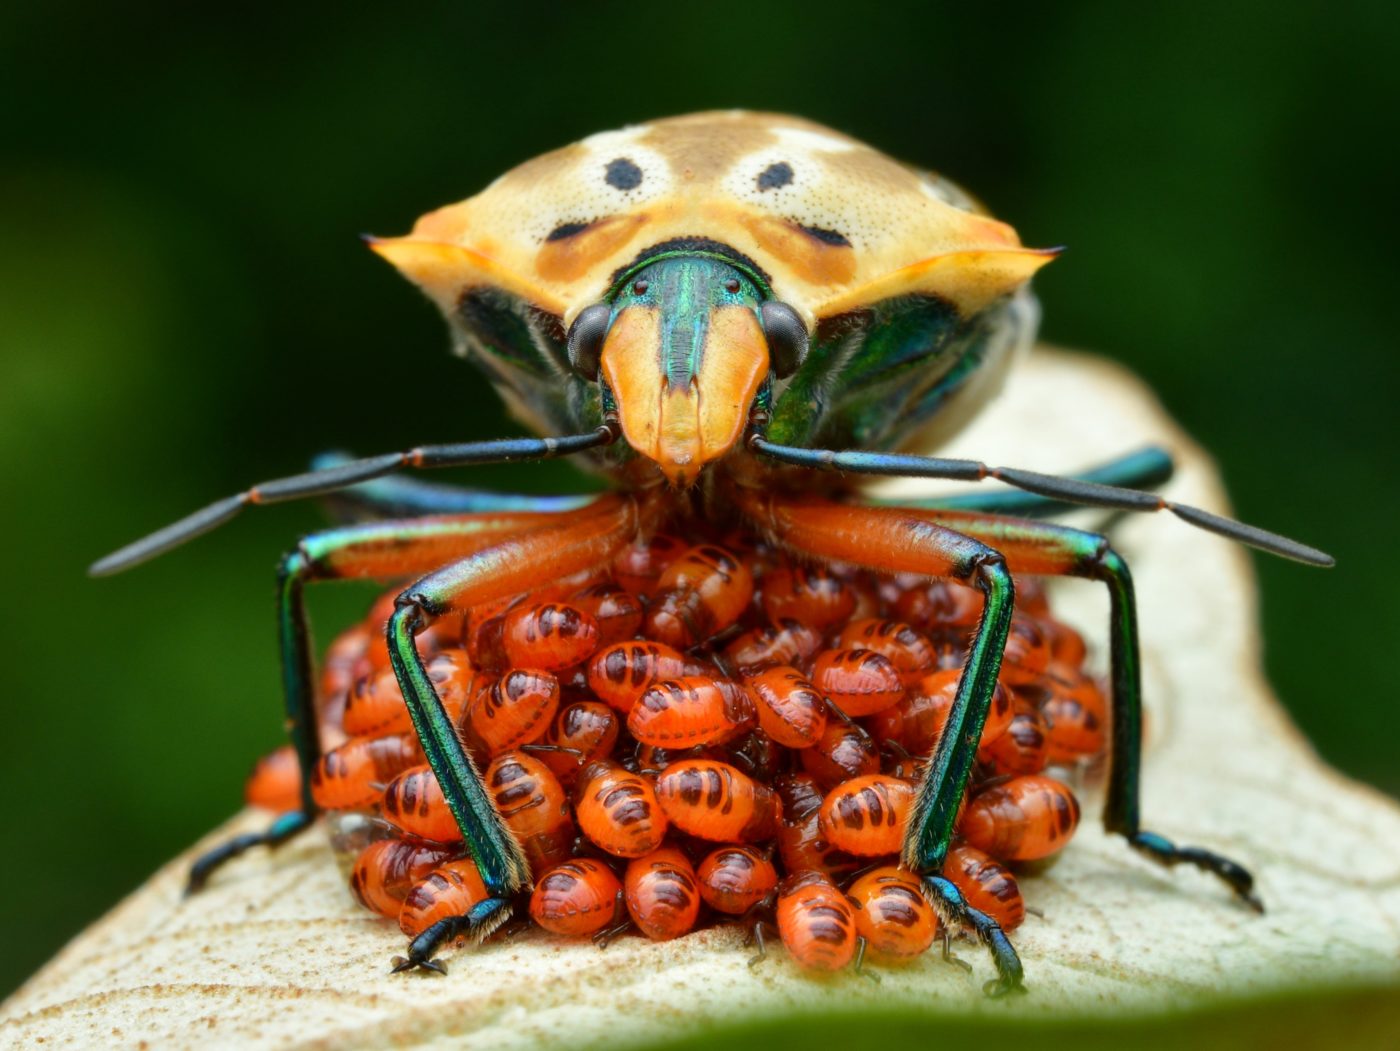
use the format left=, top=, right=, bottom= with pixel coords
left=613, top=255, right=763, bottom=389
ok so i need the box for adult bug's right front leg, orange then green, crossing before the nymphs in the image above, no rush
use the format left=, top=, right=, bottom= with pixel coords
left=735, top=488, right=1023, bottom=996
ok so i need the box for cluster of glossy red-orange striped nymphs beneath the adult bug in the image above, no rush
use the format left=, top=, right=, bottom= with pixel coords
left=248, top=535, right=1106, bottom=970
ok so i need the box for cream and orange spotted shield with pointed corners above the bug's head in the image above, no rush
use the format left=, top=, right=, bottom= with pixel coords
left=372, top=111, right=1054, bottom=325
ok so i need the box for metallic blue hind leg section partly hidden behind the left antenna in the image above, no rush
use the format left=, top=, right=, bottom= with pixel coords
left=311, top=452, right=594, bottom=522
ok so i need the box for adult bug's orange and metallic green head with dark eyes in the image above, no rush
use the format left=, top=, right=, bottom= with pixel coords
left=568, top=253, right=806, bottom=487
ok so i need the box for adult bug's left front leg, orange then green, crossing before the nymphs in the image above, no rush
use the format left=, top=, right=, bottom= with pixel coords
left=388, top=497, right=644, bottom=971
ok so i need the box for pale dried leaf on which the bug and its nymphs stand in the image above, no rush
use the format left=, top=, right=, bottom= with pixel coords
left=0, top=350, right=1400, bottom=1048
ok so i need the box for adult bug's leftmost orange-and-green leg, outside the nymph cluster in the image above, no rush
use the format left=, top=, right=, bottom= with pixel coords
left=186, top=514, right=565, bottom=893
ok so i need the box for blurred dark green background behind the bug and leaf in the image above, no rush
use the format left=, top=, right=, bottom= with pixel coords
left=0, top=0, right=1400, bottom=994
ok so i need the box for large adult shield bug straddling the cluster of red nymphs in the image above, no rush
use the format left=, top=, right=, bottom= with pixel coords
left=94, top=112, right=1331, bottom=994
